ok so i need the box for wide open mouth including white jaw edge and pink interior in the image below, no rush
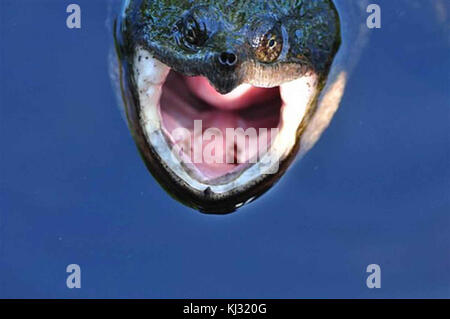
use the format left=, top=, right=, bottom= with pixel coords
left=134, top=48, right=318, bottom=193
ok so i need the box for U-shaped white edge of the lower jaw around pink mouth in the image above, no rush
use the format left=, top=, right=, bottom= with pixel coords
left=133, top=47, right=318, bottom=199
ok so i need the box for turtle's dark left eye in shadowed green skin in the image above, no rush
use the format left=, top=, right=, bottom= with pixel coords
left=175, top=15, right=208, bottom=51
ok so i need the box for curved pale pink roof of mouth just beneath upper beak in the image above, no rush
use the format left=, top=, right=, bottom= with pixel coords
left=186, top=76, right=276, bottom=110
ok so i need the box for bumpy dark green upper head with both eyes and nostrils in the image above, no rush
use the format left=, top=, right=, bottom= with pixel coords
left=121, top=0, right=340, bottom=94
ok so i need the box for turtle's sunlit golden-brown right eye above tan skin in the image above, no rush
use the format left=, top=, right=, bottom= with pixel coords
left=251, top=23, right=283, bottom=63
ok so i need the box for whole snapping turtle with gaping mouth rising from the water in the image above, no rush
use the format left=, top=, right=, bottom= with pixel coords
left=110, top=0, right=364, bottom=214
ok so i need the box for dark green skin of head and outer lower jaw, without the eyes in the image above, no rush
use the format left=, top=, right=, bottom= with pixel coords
left=115, top=0, right=341, bottom=214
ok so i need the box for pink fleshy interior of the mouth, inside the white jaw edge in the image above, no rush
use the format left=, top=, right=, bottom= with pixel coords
left=159, top=71, right=282, bottom=184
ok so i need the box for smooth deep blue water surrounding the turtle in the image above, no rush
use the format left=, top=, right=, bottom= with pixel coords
left=0, top=0, right=450, bottom=298
